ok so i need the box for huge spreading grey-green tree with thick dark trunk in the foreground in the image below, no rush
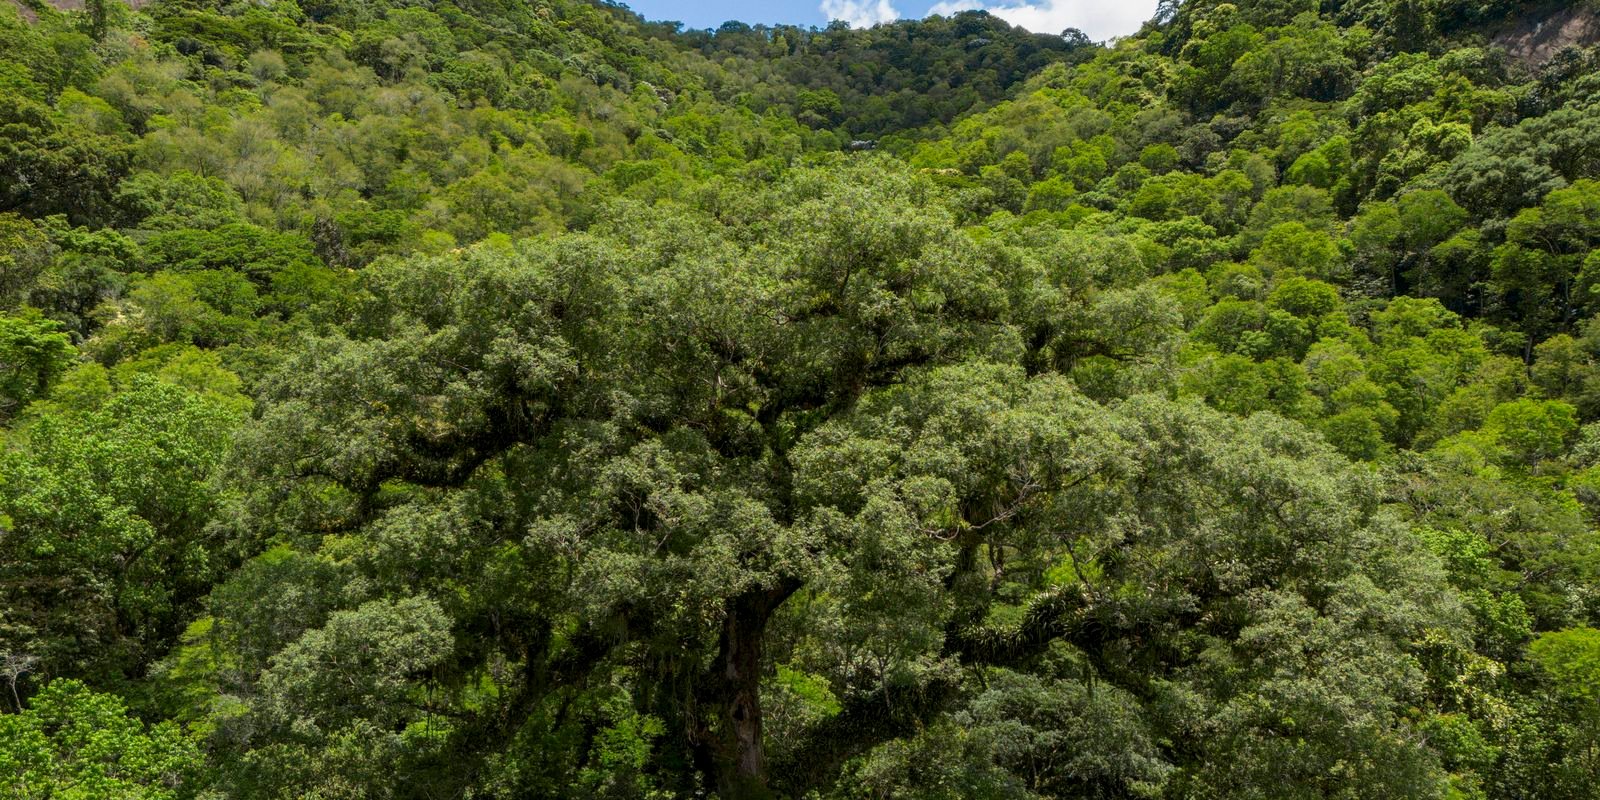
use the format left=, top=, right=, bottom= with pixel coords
left=184, top=165, right=1458, bottom=798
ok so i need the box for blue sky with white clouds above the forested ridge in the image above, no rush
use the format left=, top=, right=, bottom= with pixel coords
left=624, top=0, right=1155, bottom=40
